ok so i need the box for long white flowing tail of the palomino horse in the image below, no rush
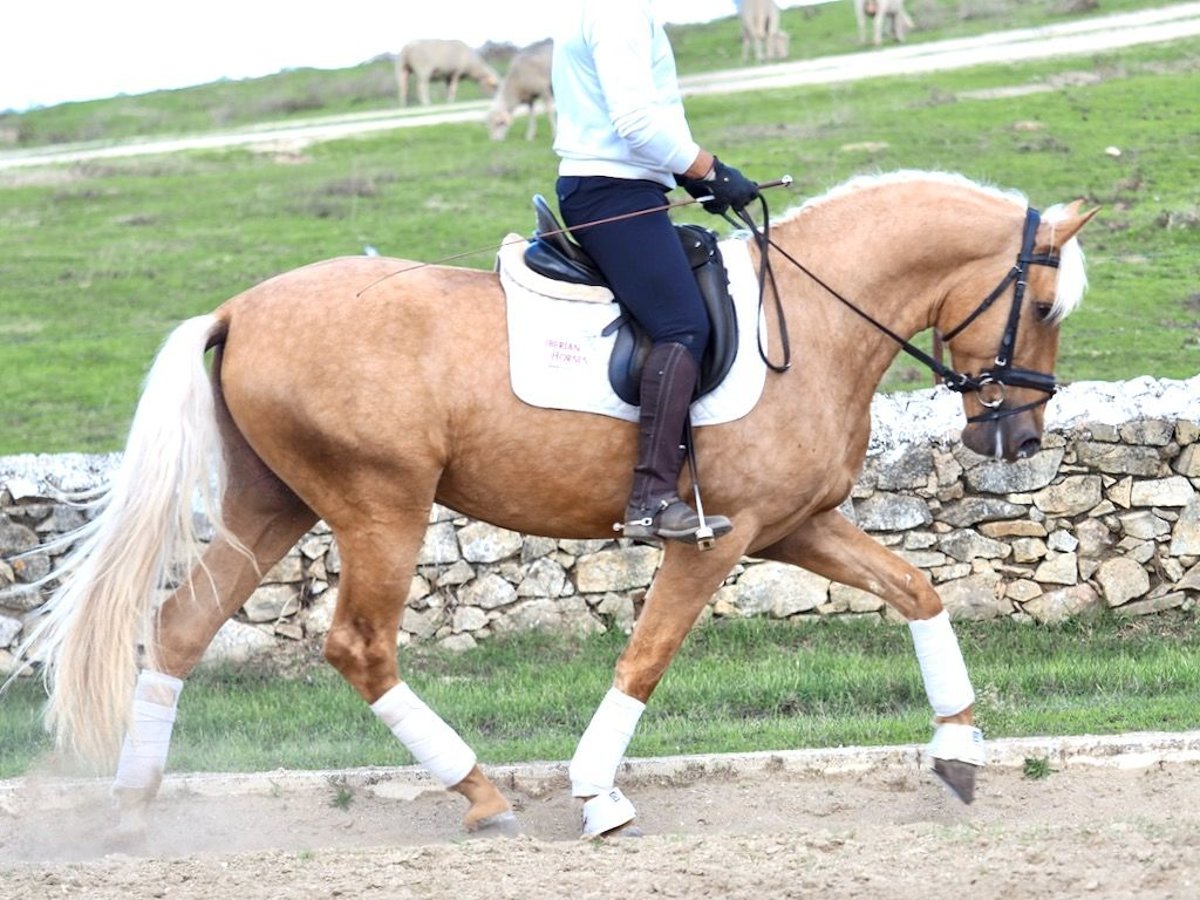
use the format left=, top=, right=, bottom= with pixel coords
left=23, top=314, right=224, bottom=767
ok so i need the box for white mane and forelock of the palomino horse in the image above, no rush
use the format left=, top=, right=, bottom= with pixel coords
left=775, top=169, right=1087, bottom=323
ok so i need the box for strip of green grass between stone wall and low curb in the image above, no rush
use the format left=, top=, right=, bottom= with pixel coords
left=0, top=611, right=1200, bottom=777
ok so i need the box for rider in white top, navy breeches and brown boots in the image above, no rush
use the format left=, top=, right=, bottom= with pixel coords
left=551, top=0, right=758, bottom=541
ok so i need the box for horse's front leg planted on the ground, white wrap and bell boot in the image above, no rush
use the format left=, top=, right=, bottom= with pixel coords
left=569, top=529, right=745, bottom=838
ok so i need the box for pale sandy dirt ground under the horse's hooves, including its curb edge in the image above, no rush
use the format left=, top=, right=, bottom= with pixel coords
left=0, top=732, right=1200, bottom=900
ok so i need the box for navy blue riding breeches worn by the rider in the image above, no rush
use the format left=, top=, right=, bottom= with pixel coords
left=556, top=175, right=709, bottom=366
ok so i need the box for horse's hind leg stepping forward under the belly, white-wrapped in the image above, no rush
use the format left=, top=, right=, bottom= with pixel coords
left=325, top=508, right=517, bottom=834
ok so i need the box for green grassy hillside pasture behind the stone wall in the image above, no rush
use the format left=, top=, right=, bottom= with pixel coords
left=0, top=0, right=1200, bottom=454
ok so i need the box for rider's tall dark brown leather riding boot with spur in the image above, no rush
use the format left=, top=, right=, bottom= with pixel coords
left=622, top=343, right=733, bottom=542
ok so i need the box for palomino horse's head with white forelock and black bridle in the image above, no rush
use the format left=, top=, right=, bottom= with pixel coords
left=942, top=200, right=1098, bottom=460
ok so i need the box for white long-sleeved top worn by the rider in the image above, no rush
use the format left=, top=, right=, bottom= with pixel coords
left=551, top=0, right=700, bottom=187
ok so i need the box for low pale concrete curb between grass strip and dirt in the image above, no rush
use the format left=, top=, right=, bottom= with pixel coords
left=0, top=731, right=1200, bottom=815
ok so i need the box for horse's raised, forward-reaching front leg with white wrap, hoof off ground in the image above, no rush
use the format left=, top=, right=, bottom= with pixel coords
left=755, top=510, right=984, bottom=803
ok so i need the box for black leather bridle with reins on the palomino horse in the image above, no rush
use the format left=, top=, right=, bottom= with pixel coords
left=730, top=201, right=1058, bottom=424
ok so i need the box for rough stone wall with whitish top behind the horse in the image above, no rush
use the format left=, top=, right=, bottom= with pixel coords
left=0, top=376, right=1200, bottom=670
